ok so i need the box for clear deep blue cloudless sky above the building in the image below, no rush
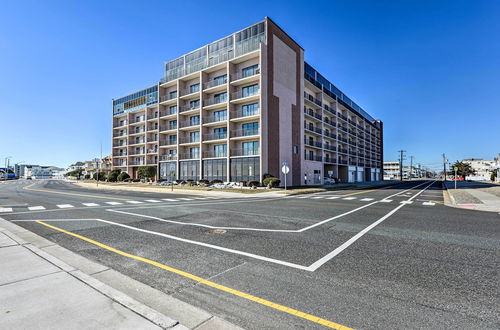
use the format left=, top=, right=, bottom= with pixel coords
left=0, top=0, right=500, bottom=168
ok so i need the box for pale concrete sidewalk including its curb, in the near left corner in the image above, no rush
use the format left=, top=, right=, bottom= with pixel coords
left=0, top=218, right=241, bottom=330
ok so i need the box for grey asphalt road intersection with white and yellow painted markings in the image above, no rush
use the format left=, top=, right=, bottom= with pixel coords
left=0, top=180, right=500, bottom=329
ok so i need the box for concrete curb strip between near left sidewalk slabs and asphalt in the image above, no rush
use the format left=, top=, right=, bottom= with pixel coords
left=0, top=217, right=241, bottom=330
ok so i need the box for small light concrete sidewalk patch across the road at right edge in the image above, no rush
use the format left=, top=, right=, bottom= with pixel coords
left=445, top=181, right=500, bottom=212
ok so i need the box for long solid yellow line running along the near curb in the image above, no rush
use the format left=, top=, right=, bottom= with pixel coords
left=36, top=220, right=351, bottom=330
